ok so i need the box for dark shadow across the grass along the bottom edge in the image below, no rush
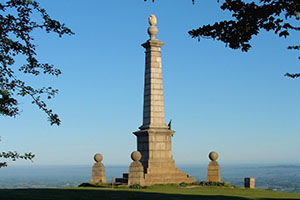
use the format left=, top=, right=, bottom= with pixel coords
left=0, top=189, right=300, bottom=200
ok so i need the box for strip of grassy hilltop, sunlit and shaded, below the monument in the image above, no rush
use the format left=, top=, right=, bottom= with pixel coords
left=0, top=185, right=300, bottom=200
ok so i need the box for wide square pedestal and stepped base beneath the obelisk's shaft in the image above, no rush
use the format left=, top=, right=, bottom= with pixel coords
left=133, top=127, right=196, bottom=185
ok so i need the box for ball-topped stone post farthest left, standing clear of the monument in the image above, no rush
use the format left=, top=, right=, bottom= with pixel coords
left=91, top=153, right=106, bottom=183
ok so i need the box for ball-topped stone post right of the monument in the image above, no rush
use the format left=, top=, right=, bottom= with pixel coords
left=207, top=151, right=221, bottom=182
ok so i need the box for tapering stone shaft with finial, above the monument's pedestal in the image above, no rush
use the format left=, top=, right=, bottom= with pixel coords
left=140, top=15, right=168, bottom=130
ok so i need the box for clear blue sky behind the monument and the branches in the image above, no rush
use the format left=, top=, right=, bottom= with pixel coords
left=0, top=0, right=300, bottom=165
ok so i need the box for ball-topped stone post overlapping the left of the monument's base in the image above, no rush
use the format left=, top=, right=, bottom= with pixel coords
left=128, top=151, right=145, bottom=185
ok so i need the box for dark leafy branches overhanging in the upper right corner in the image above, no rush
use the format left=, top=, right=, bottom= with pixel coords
left=189, top=0, right=300, bottom=78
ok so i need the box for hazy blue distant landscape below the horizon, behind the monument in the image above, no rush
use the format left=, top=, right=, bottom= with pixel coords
left=0, top=165, right=300, bottom=192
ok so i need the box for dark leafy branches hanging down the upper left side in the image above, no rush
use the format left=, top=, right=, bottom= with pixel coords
left=0, top=0, right=73, bottom=125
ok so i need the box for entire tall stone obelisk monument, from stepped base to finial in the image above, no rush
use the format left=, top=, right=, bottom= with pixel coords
left=133, top=15, right=195, bottom=185
